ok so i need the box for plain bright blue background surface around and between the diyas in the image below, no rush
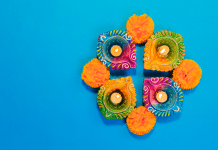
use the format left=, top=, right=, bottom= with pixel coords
left=0, top=0, right=218, bottom=150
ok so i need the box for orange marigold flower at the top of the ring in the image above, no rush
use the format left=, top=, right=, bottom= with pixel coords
left=126, top=14, right=154, bottom=43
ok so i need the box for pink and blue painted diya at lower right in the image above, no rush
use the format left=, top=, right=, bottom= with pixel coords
left=143, top=77, right=183, bottom=117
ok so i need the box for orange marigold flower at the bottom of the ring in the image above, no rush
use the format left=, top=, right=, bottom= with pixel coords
left=126, top=106, right=156, bottom=135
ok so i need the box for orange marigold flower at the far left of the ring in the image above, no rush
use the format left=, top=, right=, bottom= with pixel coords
left=82, top=58, right=110, bottom=88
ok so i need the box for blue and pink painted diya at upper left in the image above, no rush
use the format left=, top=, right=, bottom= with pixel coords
left=97, top=30, right=136, bottom=70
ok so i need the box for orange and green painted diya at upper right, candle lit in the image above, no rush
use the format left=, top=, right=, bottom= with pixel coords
left=144, top=30, right=185, bottom=71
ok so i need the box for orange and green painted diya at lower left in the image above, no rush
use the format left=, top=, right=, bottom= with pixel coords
left=97, top=77, right=136, bottom=119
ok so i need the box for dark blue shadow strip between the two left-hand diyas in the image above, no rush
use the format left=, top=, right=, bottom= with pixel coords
left=110, top=68, right=136, bottom=77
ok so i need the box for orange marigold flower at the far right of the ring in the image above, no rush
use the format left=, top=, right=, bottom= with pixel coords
left=173, top=59, right=202, bottom=89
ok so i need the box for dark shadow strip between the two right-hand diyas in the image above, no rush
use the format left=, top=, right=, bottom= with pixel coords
left=143, top=69, right=173, bottom=78
